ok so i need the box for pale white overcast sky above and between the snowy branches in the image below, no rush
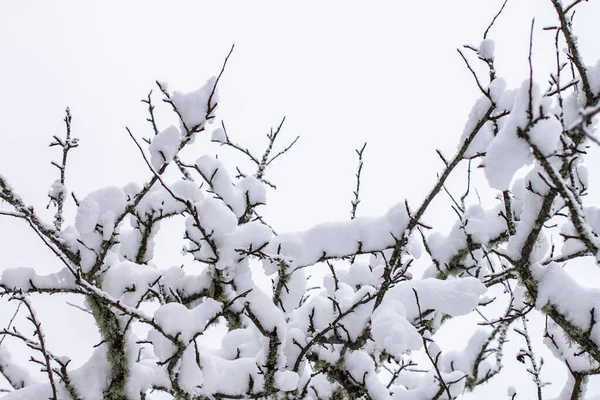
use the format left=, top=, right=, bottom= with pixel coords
left=0, top=0, right=600, bottom=396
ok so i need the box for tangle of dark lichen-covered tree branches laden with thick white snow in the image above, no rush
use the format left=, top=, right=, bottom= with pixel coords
left=0, top=0, right=600, bottom=400
